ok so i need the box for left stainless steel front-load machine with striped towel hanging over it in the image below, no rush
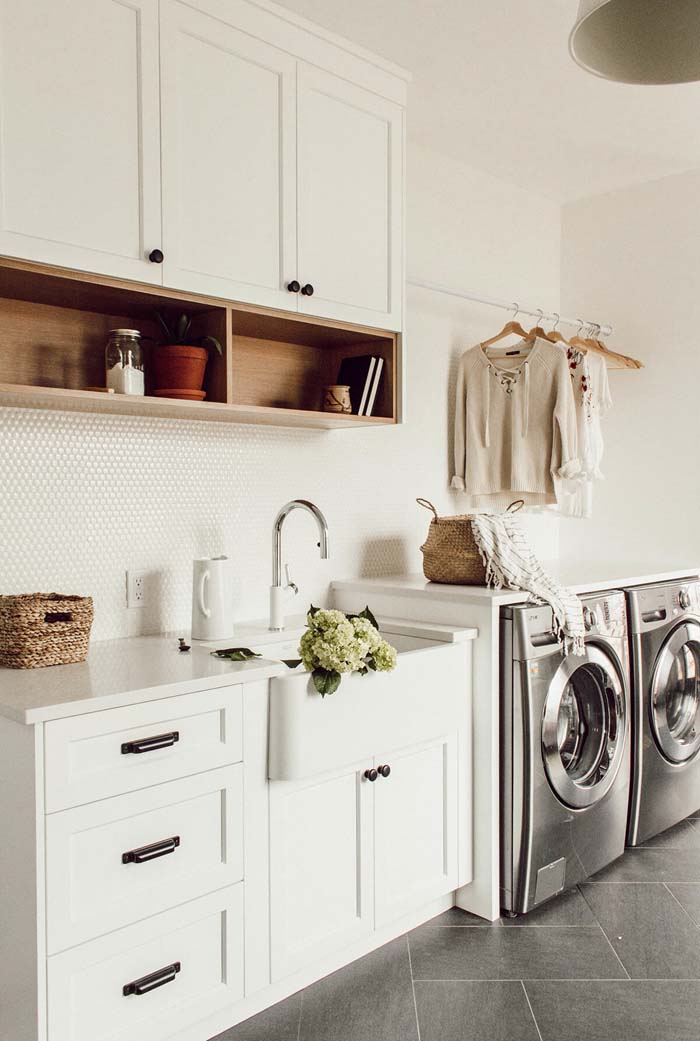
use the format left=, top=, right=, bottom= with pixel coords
left=500, top=591, right=630, bottom=913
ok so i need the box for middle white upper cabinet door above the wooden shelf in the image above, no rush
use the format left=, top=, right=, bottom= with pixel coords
left=161, top=0, right=297, bottom=310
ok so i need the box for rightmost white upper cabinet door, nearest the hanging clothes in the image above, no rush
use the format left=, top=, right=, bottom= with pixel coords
left=297, top=62, right=403, bottom=329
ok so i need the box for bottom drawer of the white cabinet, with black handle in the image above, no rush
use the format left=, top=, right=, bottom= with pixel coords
left=48, top=883, right=244, bottom=1041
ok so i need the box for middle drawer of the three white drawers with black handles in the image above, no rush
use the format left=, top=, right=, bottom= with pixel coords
left=46, top=764, right=243, bottom=954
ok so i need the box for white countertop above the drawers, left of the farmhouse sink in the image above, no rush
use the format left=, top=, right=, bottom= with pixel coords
left=0, top=633, right=286, bottom=723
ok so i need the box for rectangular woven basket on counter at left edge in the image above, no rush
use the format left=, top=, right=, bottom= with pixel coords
left=0, top=592, right=94, bottom=668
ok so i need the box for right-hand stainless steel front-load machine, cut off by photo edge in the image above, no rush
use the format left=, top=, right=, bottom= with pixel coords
left=627, top=579, right=700, bottom=845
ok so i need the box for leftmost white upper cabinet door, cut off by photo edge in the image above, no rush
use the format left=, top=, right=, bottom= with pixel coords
left=0, top=0, right=161, bottom=282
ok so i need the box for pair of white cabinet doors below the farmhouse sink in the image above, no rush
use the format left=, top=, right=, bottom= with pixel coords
left=270, top=733, right=459, bottom=981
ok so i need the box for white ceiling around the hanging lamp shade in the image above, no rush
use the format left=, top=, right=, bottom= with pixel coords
left=283, top=0, right=700, bottom=202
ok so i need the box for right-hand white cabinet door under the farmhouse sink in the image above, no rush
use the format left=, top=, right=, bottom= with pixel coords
left=373, top=734, right=459, bottom=926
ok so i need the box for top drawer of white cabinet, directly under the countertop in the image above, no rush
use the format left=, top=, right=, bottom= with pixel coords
left=46, top=686, right=243, bottom=813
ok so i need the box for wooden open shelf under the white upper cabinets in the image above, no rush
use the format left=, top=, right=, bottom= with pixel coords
left=0, top=257, right=398, bottom=429
